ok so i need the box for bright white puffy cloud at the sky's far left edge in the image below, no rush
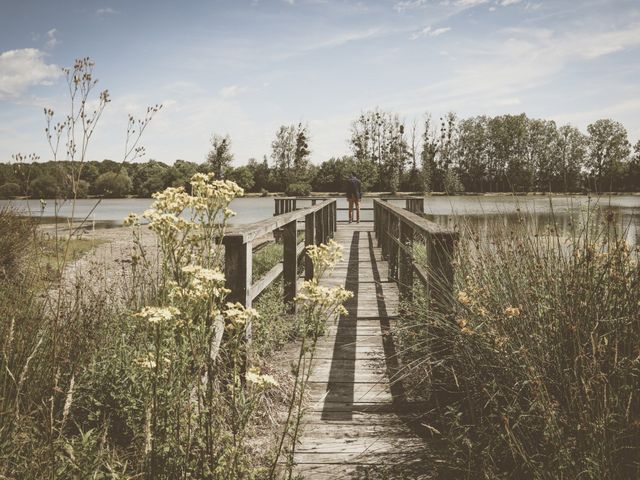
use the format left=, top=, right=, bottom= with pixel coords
left=0, top=48, right=62, bottom=99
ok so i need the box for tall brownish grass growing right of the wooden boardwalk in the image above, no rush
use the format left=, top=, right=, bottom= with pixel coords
left=399, top=204, right=640, bottom=479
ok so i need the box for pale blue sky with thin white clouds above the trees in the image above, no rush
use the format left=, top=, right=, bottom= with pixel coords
left=0, top=0, right=640, bottom=165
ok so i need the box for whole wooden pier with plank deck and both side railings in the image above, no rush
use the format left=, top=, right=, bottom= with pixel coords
left=225, top=197, right=457, bottom=479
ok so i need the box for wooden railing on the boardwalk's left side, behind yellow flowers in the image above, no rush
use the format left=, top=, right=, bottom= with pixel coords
left=223, top=198, right=336, bottom=307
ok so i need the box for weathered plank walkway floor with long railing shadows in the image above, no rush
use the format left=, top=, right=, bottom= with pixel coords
left=295, top=223, right=427, bottom=479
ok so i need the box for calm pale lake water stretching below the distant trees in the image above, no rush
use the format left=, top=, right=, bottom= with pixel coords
left=0, top=195, right=640, bottom=245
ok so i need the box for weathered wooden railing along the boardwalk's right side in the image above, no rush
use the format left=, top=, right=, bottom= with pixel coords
left=373, top=198, right=458, bottom=311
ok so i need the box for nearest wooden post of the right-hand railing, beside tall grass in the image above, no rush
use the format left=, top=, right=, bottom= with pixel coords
left=427, top=233, right=457, bottom=312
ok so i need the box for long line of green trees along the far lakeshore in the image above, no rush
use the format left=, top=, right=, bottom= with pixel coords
left=0, top=109, right=640, bottom=198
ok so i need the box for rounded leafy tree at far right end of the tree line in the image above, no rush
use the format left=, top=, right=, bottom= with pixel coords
left=587, top=119, right=631, bottom=190
